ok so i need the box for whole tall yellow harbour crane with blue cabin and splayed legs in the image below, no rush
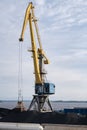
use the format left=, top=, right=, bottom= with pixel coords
left=19, top=2, right=55, bottom=112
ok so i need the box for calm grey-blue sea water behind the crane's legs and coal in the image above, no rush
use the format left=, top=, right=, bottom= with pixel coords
left=0, top=101, right=87, bottom=111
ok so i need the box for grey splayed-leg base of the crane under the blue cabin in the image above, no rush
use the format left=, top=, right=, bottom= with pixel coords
left=28, top=95, right=53, bottom=112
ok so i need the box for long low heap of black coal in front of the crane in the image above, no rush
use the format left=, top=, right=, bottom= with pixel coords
left=0, top=109, right=87, bottom=125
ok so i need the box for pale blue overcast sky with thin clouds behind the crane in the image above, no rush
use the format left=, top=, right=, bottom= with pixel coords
left=0, top=0, right=87, bottom=100
